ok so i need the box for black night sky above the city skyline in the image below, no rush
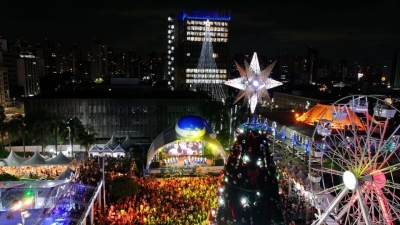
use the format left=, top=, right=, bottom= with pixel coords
left=0, top=0, right=400, bottom=63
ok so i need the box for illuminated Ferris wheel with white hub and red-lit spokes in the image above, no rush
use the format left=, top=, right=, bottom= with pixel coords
left=309, top=95, right=400, bottom=225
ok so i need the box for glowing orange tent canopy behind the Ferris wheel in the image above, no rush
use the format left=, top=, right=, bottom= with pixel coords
left=296, top=104, right=373, bottom=131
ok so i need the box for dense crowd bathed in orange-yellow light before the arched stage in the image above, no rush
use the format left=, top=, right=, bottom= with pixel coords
left=96, top=176, right=219, bottom=225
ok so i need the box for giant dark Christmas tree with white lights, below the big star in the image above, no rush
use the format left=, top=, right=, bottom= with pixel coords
left=215, top=123, right=283, bottom=225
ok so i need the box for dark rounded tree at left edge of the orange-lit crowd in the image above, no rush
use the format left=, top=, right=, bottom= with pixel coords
left=110, top=176, right=140, bottom=201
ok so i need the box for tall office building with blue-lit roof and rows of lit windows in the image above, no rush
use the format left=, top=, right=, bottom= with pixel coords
left=174, top=10, right=231, bottom=89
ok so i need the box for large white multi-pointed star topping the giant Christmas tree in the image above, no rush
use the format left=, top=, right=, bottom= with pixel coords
left=224, top=53, right=282, bottom=114
